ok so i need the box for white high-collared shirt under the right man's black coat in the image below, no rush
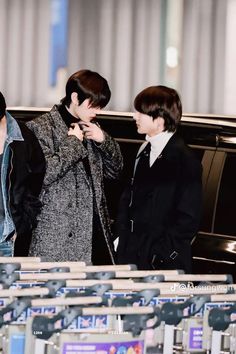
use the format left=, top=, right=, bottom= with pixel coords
left=146, top=131, right=174, bottom=167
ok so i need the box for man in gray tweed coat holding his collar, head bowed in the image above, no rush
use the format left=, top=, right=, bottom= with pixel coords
left=27, top=70, right=123, bottom=264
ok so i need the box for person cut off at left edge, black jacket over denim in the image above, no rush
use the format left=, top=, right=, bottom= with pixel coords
left=0, top=92, right=45, bottom=256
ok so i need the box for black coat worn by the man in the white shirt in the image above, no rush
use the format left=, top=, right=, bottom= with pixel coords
left=115, top=134, right=202, bottom=272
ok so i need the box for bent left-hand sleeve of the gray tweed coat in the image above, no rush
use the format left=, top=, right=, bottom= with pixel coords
left=27, top=117, right=87, bottom=186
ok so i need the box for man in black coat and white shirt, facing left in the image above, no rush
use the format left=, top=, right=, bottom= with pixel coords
left=116, top=86, right=202, bottom=272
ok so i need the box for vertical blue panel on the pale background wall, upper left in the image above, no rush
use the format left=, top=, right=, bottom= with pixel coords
left=50, top=0, right=68, bottom=86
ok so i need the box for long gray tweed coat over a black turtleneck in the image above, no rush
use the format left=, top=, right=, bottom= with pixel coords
left=27, top=106, right=123, bottom=264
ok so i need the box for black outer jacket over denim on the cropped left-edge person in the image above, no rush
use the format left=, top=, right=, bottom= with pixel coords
left=7, top=122, right=46, bottom=256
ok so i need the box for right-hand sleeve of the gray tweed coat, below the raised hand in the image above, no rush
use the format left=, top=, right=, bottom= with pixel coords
left=95, top=132, right=123, bottom=179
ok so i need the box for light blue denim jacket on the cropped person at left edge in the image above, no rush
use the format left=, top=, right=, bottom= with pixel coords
left=0, top=112, right=24, bottom=242
